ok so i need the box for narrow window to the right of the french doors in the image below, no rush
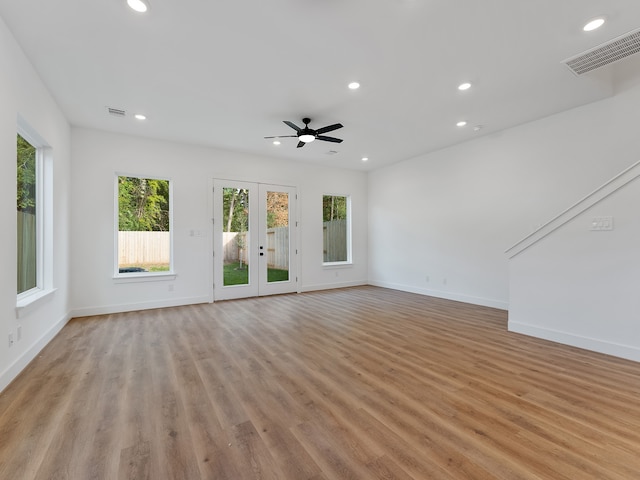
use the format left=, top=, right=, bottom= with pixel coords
left=322, top=195, right=351, bottom=265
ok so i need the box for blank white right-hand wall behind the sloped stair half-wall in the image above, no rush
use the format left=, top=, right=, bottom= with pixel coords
left=369, top=77, right=640, bottom=309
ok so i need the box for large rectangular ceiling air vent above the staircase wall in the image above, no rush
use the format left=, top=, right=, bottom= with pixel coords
left=564, top=29, right=640, bottom=75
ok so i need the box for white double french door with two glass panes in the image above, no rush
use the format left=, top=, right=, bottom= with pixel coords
left=213, top=180, right=297, bottom=300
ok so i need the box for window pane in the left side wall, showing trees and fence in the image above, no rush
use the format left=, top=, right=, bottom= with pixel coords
left=17, top=135, right=38, bottom=293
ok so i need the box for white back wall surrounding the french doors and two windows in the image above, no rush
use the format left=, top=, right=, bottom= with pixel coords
left=71, top=128, right=368, bottom=315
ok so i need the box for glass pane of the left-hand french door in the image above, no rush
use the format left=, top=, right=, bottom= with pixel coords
left=222, top=187, right=250, bottom=286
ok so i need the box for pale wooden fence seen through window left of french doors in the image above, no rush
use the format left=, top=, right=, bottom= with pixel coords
left=118, top=232, right=171, bottom=266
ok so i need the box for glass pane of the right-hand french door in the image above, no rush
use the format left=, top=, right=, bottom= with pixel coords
left=266, top=191, right=289, bottom=283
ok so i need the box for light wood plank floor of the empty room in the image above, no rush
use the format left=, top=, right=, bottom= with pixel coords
left=0, top=287, right=640, bottom=480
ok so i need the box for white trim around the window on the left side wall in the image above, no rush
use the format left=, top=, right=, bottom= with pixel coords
left=16, top=115, right=56, bottom=308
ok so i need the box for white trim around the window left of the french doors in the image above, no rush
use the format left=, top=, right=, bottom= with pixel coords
left=112, top=172, right=177, bottom=283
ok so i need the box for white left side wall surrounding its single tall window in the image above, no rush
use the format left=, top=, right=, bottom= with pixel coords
left=0, top=19, right=70, bottom=390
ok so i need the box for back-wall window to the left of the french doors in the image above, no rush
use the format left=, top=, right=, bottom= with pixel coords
left=116, top=176, right=173, bottom=276
